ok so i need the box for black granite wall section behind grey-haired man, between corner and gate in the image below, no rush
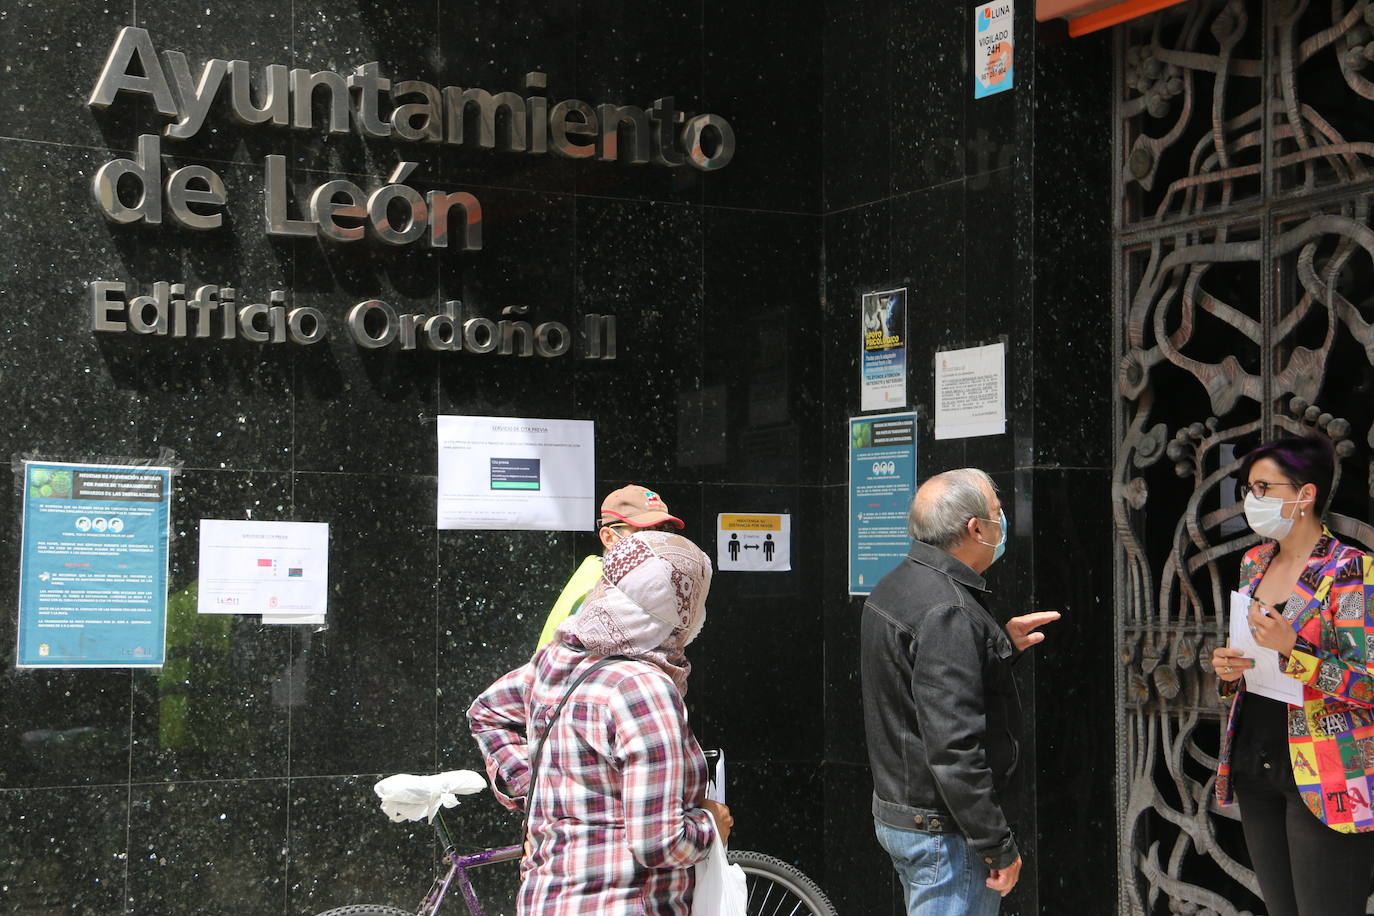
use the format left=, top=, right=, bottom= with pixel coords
left=823, top=0, right=1116, bottom=915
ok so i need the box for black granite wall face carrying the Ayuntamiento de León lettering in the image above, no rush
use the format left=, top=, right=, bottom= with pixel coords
left=0, top=0, right=824, bottom=915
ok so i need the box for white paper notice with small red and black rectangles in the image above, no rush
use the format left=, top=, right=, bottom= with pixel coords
left=196, top=519, right=330, bottom=623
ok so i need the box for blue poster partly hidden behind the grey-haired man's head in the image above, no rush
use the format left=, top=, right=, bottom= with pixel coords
left=849, top=413, right=916, bottom=595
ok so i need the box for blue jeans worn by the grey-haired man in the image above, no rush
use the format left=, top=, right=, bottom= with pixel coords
left=874, top=821, right=1002, bottom=916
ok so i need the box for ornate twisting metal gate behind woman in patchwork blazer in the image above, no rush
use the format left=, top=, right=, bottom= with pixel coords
left=1112, top=0, right=1374, bottom=915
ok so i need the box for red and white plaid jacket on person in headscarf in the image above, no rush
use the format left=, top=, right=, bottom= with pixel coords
left=467, top=641, right=714, bottom=916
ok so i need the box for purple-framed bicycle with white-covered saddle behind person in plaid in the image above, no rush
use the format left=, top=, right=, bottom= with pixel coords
left=311, top=770, right=835, bottom=916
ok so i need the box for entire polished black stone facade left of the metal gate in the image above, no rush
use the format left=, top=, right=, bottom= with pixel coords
left=0, top=0, right=1114, bottom=915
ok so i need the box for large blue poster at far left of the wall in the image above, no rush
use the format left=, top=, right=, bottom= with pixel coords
left=18, top=461, right=172, bottom=667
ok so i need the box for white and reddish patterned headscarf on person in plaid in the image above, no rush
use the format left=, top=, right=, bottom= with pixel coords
left=558, top=531, right=710, bottom=695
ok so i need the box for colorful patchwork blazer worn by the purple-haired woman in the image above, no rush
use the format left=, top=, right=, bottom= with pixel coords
left=1216, top=529, right=1374, bottom=834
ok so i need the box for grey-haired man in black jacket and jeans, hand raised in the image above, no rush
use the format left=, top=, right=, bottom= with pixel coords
left=861, top=468, right=1059, bottom=916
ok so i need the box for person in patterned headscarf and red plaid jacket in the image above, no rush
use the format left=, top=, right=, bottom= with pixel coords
left=467, top=531, right=732, bottom=916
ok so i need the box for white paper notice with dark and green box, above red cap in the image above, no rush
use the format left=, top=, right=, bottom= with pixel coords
left=438, top=416, right=598, bottom=531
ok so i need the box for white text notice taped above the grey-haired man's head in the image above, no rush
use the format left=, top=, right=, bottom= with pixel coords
left=936, top=343, right=1007, bottom=439
